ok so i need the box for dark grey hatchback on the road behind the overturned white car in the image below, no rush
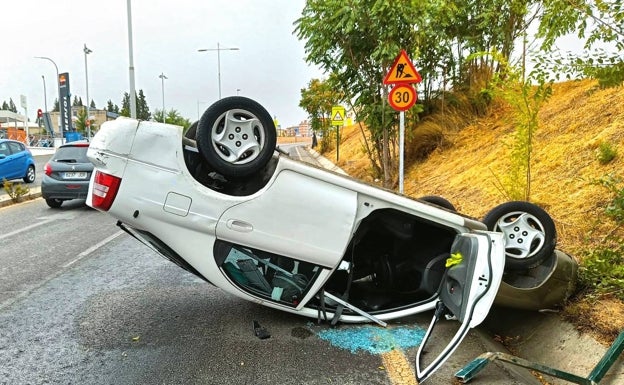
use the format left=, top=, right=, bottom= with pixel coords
left=41, top=141, right=93, bottom=208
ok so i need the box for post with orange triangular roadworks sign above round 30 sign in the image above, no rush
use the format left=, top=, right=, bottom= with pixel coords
left=383, top=50, right=422, bottom=194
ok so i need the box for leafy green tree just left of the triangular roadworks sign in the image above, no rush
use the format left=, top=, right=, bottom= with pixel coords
left=295, top=0, right=425, bottom=187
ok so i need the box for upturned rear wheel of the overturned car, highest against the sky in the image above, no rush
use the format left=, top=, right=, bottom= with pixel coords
left=196, top=96, right=277, bottom=178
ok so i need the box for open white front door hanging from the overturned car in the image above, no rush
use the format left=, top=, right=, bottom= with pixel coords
left=416, top=232, right=505, bottom=383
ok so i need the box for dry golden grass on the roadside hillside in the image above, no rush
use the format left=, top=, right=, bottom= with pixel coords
left=324, top=80, right=624, bottom=342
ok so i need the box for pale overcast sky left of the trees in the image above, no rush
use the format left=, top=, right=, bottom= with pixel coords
left=0, top=0, right=323, bottom=127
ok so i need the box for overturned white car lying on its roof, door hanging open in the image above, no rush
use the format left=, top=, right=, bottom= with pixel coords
left=87, top=97, right=576, bottom=381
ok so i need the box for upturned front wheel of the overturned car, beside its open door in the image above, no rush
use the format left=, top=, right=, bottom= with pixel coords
left=483, top=201, right=557, bottom=270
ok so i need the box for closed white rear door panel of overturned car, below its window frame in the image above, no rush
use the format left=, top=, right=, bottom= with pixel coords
left=216, top=170, right=357, bottom=269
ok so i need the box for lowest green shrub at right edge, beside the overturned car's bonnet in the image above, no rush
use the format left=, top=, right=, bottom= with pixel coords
left=579, top=240, right=624, bottom=300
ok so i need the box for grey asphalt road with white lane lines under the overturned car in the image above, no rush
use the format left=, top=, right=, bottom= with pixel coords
left=0, top=149, right=536, bottom=385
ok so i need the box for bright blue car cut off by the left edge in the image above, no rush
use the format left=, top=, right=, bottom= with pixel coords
left=0, top=139, right=35, bottom=183
